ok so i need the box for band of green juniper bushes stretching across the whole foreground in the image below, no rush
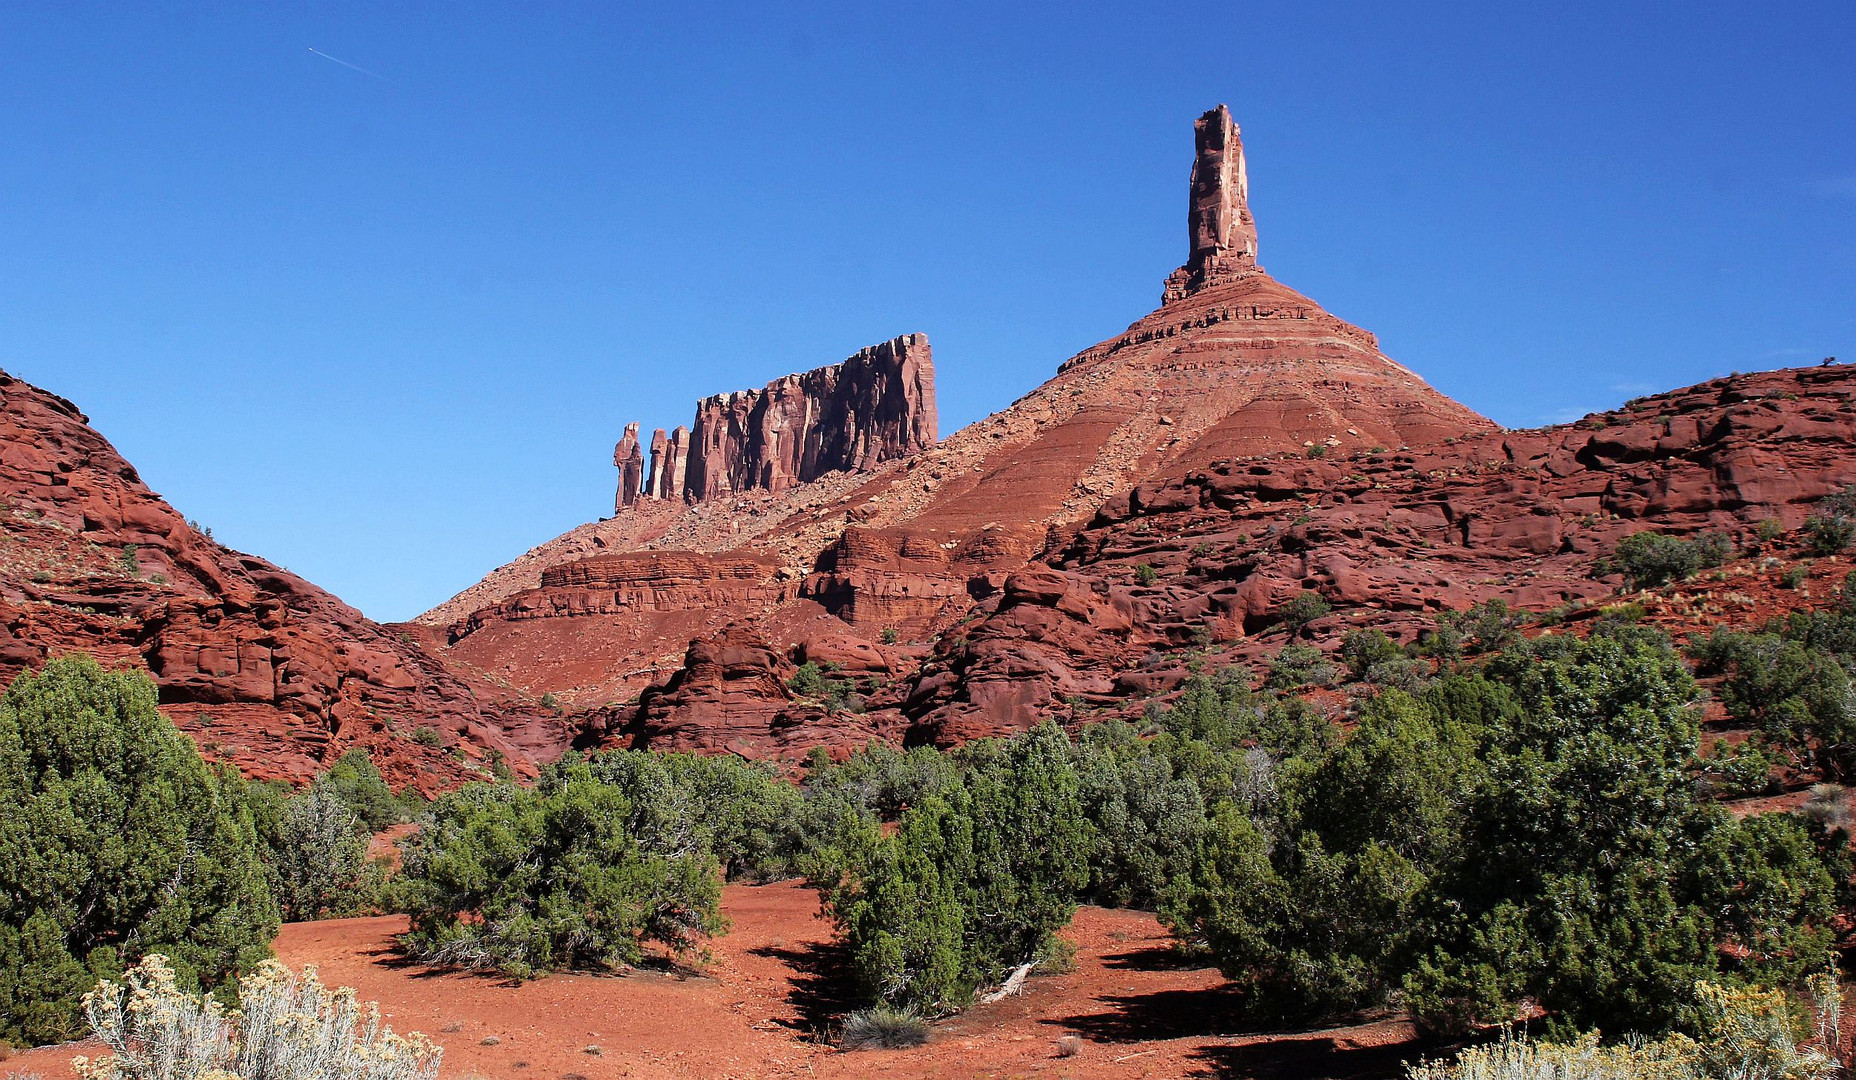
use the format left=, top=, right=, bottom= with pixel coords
left=0, top=603, right=1856, bottom=1080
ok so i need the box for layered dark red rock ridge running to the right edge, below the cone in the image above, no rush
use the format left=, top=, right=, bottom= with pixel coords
left=890, top=367, right=1856, bottom=742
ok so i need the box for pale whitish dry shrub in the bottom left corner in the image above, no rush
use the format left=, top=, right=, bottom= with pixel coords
left=74, top=956, right=444, bottom=1080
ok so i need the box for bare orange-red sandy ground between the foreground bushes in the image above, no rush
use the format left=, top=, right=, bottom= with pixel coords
left=0, top=883, right=1422, bottom=1080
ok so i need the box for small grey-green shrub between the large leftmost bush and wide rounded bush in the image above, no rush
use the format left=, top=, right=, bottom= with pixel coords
left=267, top=778, right=386, bottom=920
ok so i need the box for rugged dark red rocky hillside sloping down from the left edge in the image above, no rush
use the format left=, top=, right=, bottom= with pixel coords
left=0, top=373, right=572, bottom=792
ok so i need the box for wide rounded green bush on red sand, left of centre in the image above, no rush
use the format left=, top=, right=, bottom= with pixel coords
left=403, top=761, right=724, bottom=978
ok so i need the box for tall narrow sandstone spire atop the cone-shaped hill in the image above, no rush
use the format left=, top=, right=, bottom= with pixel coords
left=1164, top=106, right=1260, bottom=302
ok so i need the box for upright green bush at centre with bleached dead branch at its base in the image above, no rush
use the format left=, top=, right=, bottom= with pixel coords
left=822, top=724, right=1089, bottom=1013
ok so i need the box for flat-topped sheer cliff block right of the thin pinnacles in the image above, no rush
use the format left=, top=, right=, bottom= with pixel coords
left=687, top=334, right=935, bottom=501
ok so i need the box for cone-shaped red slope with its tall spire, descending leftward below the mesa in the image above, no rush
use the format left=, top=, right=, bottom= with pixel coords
left=419, top=108, right=1494, bottom=727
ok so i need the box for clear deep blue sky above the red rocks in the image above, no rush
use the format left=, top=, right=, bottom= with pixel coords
left=0, top=0, right=1856, bottom=620
